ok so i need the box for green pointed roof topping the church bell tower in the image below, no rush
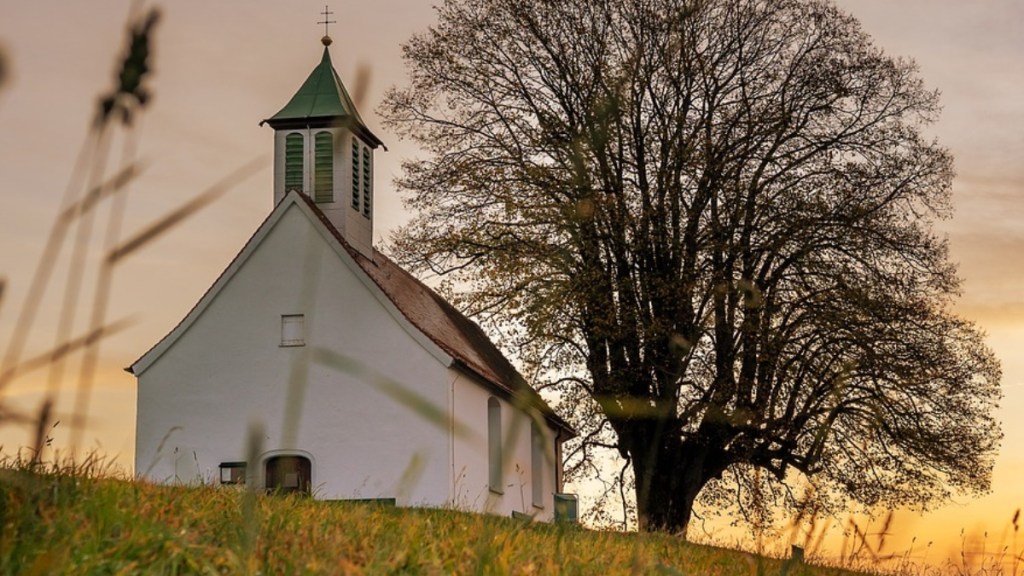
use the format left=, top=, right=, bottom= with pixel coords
left=260, top=46, right=383, bottom=148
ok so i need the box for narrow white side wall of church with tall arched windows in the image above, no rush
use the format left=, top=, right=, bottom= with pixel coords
left=450, top=369, right=557, bottom=522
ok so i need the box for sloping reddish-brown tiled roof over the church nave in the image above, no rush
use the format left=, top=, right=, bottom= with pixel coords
left=298, top=194, right=575, bottom=436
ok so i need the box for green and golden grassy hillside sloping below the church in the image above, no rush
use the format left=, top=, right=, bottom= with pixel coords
left=0, top=457, right=864, bottom=575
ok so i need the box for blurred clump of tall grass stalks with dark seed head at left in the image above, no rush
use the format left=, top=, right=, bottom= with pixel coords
left=0, top=2, right=265, bottom=460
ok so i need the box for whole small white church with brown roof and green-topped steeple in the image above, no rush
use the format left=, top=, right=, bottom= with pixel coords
left=127, top=37, right=575, bottom=521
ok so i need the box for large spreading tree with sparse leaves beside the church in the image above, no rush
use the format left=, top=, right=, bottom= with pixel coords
left=382, top=0, right=1001, bottom=532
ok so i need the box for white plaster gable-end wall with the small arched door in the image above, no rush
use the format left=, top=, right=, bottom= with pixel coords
left=136, top=204, right=452, bottom=505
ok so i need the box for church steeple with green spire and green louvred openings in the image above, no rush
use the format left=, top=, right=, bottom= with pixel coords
left=260, top=36, right=383, bottom=257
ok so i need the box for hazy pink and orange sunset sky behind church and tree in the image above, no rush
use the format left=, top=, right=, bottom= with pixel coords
left=0, top=0, right=1024, bottom=561
